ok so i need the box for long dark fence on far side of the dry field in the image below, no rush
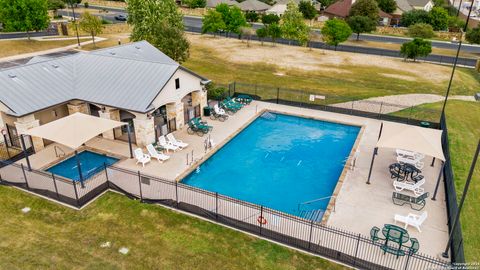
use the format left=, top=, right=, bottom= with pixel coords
left=185, top=26, right=477, bottom=67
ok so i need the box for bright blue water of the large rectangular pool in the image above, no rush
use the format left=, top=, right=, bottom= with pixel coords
left=182, top=113, right=360, bottom=216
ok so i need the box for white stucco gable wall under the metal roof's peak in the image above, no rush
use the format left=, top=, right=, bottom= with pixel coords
left=152, top=69, right=202, bottom=108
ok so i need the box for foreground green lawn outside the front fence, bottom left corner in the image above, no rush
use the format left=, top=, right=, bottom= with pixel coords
left=0, top=186, right=343, bottom=269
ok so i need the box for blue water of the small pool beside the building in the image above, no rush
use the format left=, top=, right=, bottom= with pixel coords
left=47, top=151, right=118, bottom=181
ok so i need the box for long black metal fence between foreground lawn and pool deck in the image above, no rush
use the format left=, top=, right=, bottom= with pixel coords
left=0, top=159, right=450, bottom=270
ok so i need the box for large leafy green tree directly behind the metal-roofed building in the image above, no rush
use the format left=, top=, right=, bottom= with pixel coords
left=127, top=0, right=189, bottom=62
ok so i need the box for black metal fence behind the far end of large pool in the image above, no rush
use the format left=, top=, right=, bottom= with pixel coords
left=228, top=82, right=440, bottom=128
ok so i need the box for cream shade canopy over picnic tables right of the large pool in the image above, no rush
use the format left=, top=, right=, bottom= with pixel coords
left=376, top=122, right=445, bottom=161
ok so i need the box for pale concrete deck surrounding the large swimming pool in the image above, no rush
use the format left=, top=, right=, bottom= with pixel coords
left=15, top=101, right=448, bottom=257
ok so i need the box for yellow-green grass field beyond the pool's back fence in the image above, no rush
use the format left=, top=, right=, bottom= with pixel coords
left=184, top=43, right=480, bottom=100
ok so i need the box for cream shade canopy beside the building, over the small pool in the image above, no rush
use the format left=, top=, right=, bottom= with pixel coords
left=23, top=112, right=127, bottom=149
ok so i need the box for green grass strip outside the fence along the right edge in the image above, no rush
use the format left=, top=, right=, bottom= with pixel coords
left=396, top=100, right=480, bottom=262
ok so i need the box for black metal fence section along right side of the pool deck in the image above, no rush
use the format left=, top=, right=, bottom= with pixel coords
left=440, top=114, right=465, bottom=263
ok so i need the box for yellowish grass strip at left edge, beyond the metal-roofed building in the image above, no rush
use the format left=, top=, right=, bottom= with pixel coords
left=0, top=39, right=81, bottom=57
